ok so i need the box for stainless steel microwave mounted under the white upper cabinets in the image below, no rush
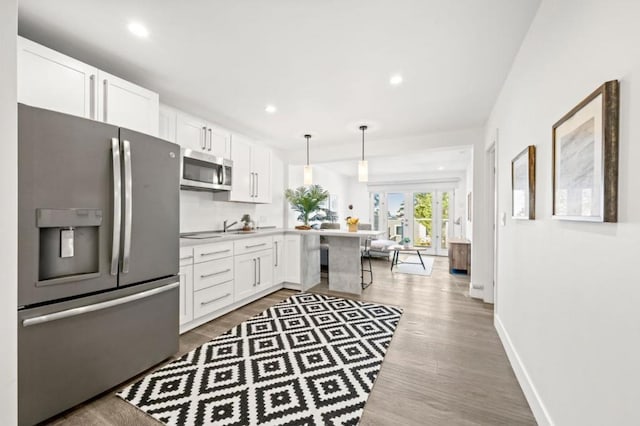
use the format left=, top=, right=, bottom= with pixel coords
left=180, top=148, right=233, bottom=191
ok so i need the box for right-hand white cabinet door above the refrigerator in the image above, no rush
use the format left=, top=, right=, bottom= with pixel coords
left=98, top=71, right=160, bottom=136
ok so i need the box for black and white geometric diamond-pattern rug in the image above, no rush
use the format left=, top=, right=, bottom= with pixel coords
left=118, top=293, right=402, bottom=426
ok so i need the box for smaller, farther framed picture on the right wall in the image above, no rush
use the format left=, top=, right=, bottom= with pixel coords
left=511, top=145, right=536, bottom=220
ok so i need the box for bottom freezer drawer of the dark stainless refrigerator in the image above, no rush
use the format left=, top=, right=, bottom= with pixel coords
left=18, top=277, right=179, bottom=425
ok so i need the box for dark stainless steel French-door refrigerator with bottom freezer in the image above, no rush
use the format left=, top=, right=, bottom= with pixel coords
left=18, top=105, right=180, bottom=424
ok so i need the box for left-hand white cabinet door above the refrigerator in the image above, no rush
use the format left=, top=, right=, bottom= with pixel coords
left=18, top=37, right=98, bottom=119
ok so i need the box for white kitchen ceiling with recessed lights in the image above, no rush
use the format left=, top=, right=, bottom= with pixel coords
left=19, top=0, right=539, bottom=149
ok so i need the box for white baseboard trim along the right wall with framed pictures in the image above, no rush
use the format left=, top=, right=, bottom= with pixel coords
left=493, top=313, right=554, bottom=426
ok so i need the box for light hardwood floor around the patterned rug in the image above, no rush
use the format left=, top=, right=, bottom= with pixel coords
left=48, top=258, right=536, bottom=426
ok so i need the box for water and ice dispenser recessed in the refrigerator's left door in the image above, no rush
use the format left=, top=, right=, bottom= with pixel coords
left=36, top=209, right=102, bottom=286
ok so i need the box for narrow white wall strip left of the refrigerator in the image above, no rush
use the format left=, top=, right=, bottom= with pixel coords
left=0, top=0, right=18, bottom=425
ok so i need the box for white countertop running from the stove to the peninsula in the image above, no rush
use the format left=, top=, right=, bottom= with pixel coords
left=180, top=228, right=384, bottom=247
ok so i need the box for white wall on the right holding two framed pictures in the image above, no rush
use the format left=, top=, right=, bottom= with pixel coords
left=488, top=0, right=640, bottom=426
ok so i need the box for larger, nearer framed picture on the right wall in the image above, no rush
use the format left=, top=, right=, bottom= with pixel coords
left=553, top=80, right=619, bottom=222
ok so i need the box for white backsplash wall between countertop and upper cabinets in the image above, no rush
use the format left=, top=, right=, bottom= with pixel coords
left=180, top=153, right=285, bottom=232
